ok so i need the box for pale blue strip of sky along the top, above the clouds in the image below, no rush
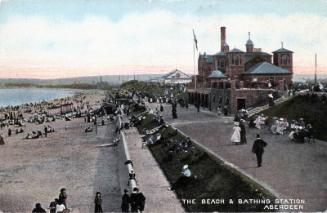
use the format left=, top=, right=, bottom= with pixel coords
left=0, top=0, right=327, bottom=21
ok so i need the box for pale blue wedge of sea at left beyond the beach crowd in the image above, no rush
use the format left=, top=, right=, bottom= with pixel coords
left=0, top=88, right=80, bottom=107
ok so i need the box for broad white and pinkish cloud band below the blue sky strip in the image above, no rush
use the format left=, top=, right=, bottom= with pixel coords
left=0, top=10, right=327, bottom=78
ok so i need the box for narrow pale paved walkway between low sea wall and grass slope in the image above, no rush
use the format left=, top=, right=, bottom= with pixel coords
left=125, top=128, right=184, bottom=212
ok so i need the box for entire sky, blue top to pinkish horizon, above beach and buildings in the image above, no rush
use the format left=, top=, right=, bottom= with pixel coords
left=0, top=0, right=327, bottom=79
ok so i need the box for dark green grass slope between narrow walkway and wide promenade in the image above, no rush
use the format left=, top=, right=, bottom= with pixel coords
left=139, top=115, right=272, bottom=212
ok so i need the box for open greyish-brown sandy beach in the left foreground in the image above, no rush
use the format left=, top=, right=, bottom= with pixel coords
left=0, top=91, right=120, bottom=212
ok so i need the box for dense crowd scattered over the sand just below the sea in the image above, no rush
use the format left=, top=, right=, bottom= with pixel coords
left=0, top=94, right=93, bottom=143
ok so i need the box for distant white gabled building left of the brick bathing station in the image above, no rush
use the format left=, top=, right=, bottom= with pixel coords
left=151, top=69, right=192, bottom=84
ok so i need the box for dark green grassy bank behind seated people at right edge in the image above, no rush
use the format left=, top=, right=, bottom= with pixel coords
left=263, top=95, right=327, bottom=141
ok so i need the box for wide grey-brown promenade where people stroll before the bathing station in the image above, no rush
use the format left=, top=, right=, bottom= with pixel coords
left=148, top=103, right=327, bottom=211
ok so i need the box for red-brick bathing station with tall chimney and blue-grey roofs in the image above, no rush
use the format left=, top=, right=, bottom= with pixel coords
left=188, top=27, right=293, bottom=112
